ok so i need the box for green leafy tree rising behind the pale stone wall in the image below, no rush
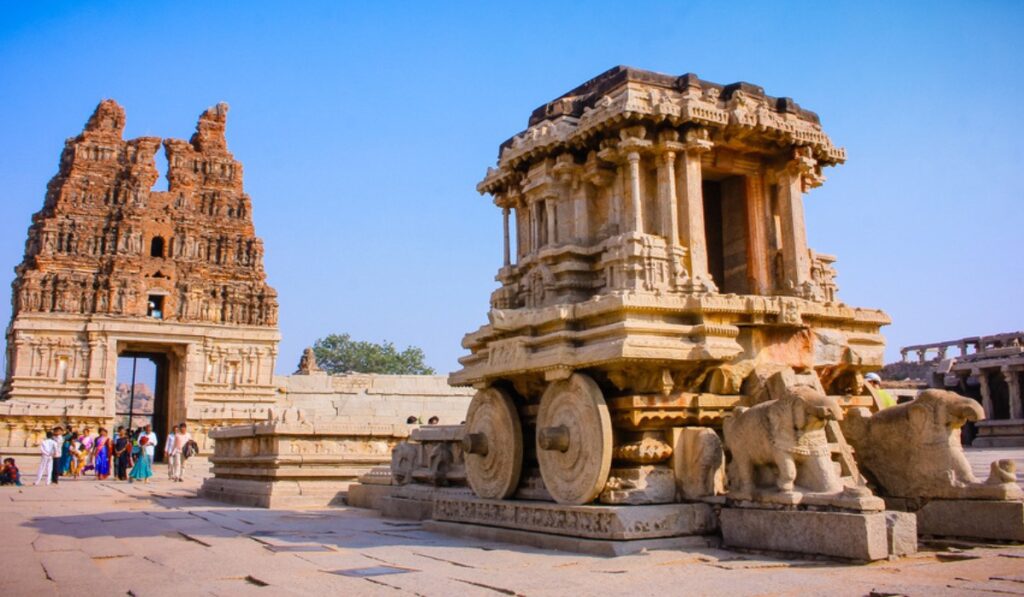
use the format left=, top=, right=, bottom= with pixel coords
left=313, top=334, right=434, bottom=375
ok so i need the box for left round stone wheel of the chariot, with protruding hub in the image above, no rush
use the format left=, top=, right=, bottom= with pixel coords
left=462, top=388, right=522, bottom=500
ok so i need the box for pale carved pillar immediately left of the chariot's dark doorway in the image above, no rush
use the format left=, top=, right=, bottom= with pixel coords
left=679, top=129, right=715, bottom=290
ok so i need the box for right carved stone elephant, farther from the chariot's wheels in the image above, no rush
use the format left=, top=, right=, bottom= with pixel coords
left=842, top=389, right=1020, bottom=499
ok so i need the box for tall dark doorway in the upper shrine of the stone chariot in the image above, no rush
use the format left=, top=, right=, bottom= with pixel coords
left=702, top=176, right=750, bottom=294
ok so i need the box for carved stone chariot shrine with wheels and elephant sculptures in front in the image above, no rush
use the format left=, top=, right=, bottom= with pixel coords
left=353, top=67, right=1024, bottom=561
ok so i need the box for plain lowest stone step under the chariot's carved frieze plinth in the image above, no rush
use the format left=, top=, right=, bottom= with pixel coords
left=423, top=520, right=718, bottom=557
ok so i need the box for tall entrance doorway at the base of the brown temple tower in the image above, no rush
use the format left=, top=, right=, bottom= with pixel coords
left=112, top=352, right=168, bottom=462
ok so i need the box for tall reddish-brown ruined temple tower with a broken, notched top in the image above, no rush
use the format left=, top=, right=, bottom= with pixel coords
left=0, top=100, right=280, bottom=454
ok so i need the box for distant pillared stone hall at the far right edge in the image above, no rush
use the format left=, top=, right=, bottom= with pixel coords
left=900, top=332, right=1024, bottom=447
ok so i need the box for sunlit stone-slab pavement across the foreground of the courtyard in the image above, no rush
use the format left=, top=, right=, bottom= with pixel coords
left=0, top=450, right=1024, bottom=597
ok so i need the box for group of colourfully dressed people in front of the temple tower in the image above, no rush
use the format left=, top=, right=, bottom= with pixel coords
left=0, top=423, right=199, bottom=485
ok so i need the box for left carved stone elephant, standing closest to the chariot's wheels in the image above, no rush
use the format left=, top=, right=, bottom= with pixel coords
left=723, top=386, right=843, bottom=499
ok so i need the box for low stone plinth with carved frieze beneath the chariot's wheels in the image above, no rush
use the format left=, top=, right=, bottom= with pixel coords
left=424, top=496, right=718, bottom=556
